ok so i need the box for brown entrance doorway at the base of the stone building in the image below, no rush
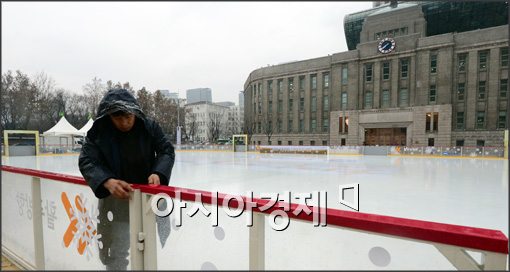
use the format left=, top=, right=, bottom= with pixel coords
left=365, top=128, right=407, bottom=145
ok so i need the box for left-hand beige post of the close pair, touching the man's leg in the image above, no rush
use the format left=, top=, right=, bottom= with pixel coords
left=129, top=189, right=145, bottom=270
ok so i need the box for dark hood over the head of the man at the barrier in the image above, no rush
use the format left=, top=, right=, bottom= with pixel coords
left=96, top=89, right=145, bottom=121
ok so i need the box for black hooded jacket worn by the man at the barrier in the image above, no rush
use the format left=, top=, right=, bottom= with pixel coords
left=78, top=89, right=175, bottom=198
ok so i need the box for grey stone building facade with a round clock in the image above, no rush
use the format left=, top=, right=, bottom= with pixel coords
left=244, top=2, right=509, bottom=146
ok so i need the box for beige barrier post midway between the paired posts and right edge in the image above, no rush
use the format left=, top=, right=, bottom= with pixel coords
left=249, top=212, right=266, bottom=270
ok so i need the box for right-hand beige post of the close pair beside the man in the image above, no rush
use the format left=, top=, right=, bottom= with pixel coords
left=142, top=193, right=157, bottom=270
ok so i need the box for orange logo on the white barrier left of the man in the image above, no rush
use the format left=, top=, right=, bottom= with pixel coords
left=61, top=192, right=103, bottom=259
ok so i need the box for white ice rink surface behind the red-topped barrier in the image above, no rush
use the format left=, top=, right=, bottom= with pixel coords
left=2, top=151, right=509, bottom=236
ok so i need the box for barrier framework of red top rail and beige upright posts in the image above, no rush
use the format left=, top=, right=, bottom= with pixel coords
left=1, top=166, right=508, bottom=270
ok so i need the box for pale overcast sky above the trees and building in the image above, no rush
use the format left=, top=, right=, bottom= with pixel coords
left=2, top=2, right=372, bottom=104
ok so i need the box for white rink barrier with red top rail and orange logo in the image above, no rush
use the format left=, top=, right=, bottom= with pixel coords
left=2, top=167, right=508, bottom=270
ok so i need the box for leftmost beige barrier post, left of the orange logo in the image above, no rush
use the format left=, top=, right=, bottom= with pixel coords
left=32, top=177, right=45, bottom=270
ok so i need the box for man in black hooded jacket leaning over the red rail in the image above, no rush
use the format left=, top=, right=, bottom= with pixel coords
left=79, top=89, right=175, bottom=270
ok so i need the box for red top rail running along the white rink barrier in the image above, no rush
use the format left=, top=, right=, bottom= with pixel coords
left=2, top=166, right=508, bottom=254
